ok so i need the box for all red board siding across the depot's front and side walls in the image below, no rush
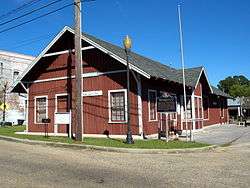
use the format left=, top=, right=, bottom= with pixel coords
left=26, top=32, right=228, bottom=135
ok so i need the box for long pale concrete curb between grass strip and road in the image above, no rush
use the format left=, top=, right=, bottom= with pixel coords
left=0, top=135, right=218, bottom=154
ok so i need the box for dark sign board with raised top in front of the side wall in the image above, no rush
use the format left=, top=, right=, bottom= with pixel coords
left=157, top=92, right=177, bottom=112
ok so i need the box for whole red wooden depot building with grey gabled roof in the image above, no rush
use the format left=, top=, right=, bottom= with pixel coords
left=12, top=27, right=228, bottom=136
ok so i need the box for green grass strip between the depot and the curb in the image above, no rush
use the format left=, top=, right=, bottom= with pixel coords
left=0, top=126, right=208, bottom=149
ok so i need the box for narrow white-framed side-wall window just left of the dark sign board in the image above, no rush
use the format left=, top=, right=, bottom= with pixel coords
left=148, top=90, right=157, bottom=121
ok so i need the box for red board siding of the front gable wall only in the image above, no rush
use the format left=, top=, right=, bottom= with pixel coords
left=29, top=47, right=139, bottom=134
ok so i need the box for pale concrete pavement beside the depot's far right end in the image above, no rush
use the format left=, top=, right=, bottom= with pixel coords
left=194, top=124, right=250, bottom=145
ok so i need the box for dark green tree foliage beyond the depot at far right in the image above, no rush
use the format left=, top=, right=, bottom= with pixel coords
left=218, top=75, right=250, bottom=97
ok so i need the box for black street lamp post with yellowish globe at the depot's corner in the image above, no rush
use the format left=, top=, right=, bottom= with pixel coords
left=123, top=35, right=134, bottom=144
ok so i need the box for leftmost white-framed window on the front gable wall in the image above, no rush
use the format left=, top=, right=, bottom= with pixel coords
left=34, top=96, right=48, bottom=124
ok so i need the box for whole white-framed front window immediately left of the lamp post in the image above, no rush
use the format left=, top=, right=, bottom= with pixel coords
left=108, top=89, right=127, bottom=123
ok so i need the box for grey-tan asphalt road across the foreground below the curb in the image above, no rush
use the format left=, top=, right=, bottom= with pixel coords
left=0, top=141, right=250, bottom=188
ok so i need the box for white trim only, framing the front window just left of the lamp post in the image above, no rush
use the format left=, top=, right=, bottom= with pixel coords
left=108, top=89, right=128, bottom=124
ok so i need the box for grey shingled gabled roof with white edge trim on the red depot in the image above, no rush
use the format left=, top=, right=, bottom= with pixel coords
left=12, top=26, right=230, bottom=98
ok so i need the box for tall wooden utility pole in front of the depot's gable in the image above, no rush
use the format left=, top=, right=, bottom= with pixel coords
left=74, top=0, right=83, bottom=141
